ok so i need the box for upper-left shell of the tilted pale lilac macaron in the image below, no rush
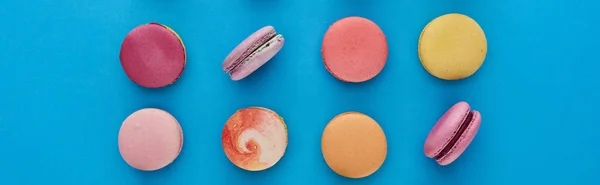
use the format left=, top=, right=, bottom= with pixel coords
left=221, top=26, right=275, bottom=72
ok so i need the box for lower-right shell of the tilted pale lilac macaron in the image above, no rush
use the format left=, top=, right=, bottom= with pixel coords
left=231, top=35, right=285, bottom=80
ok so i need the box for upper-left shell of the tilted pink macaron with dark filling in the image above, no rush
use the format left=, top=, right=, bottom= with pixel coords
left=424, top=102, right=470, bottom=158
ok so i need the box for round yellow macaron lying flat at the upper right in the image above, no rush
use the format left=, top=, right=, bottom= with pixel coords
left=418, top=13, right=487, bottom=80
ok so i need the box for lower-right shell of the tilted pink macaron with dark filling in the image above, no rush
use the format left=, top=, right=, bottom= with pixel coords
left=436, top=111, right=481, bottom=166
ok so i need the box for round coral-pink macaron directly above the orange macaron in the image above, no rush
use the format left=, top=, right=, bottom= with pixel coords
left=321, top=17, right=388, bottom=83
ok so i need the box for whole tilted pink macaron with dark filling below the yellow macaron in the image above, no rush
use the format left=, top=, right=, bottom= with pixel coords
left=424, top=102, right=481, bottom=166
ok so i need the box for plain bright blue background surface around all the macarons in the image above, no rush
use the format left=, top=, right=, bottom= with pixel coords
left=0, top=0, right=600, bottom=185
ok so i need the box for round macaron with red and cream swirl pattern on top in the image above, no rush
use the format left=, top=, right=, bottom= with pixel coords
left=221, top=107, right=288, bottom=171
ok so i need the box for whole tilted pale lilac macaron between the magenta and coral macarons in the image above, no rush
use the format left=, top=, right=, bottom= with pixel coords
left=222, top=26, right=284, bottom=81
